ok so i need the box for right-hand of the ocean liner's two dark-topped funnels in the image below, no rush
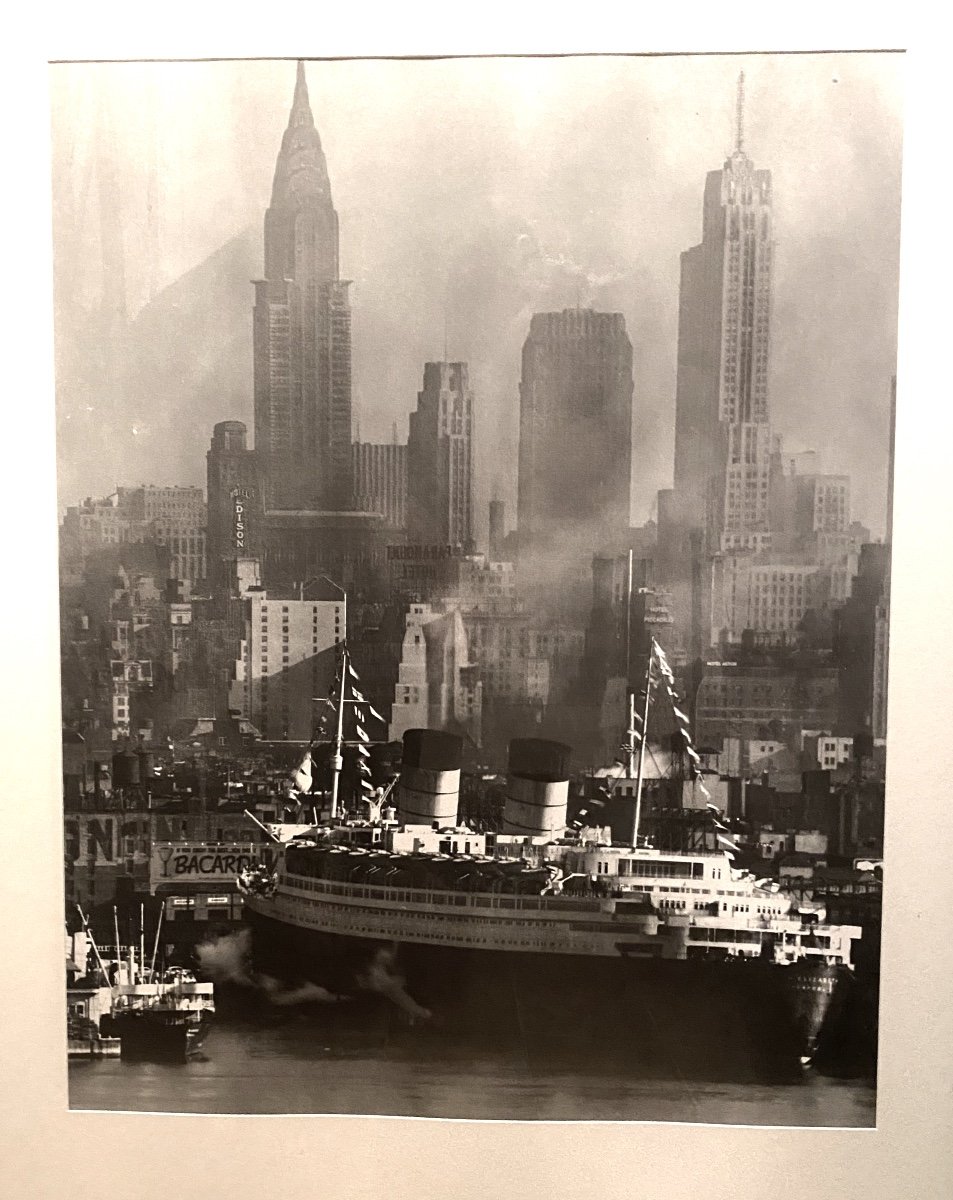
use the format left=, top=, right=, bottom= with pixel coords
left=503, top=738, right=573, bottom=838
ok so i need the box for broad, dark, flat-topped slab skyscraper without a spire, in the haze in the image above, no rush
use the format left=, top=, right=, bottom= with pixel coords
left=517, top=308, right=633, bottom=612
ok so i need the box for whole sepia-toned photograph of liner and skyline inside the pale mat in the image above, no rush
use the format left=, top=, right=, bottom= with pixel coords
left=48, top=50, right=904, bottom=1136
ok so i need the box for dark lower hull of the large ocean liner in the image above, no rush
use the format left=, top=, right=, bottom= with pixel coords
left=240, top=907, right=839, bottom=1080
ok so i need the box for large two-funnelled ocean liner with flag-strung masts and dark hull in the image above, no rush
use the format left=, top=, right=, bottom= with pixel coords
left=240, top=641, right=861, bottom=1078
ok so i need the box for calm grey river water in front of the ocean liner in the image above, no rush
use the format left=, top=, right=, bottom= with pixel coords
left=70, top=1012, right=875, bottom=1128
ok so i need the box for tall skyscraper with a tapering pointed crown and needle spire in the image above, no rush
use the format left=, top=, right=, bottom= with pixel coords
left=254, top=62, right=352, bottom=510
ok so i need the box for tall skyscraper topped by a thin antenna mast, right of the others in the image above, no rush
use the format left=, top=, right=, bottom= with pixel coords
left=675, top=73, right=774, bottom=554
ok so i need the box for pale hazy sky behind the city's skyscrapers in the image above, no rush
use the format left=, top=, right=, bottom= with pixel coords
left=50, top=54, right=903, bottom=536
